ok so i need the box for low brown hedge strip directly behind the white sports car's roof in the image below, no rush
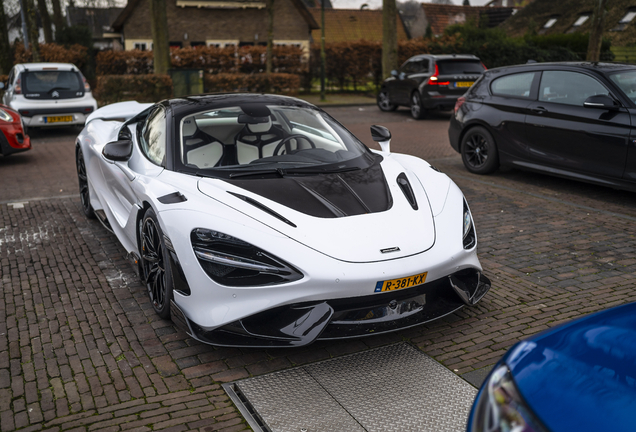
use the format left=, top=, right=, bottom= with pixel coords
left=204, top=73, right=300, bottom=95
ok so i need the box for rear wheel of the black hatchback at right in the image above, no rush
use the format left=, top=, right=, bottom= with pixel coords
left=460, top=126, right=499, bottom=174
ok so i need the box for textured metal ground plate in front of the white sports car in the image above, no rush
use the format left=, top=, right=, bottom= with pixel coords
left=224, top=343, right=477, bottom=432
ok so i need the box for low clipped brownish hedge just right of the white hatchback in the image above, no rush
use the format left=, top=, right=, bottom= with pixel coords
left=94, top=74, right=172, bottom=106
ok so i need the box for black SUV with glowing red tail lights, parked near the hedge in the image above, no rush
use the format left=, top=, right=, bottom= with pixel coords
left=378, top=54, right=486, bottom=119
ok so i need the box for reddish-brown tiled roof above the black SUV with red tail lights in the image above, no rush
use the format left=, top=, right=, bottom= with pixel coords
left=418, top=3, right=515, bottom=36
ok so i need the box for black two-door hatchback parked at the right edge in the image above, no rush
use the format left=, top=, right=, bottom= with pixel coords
left=448, top=63, right=636, bottom=191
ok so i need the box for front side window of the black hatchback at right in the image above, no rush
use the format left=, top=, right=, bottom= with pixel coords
left=539, top=71, right=609, bottom=106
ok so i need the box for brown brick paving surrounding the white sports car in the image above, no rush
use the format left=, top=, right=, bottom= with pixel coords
left=0, top=107, right=636, bottom=432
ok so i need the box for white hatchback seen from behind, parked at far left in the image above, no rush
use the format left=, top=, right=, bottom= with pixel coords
left=2, top=63, right=97, bottom=127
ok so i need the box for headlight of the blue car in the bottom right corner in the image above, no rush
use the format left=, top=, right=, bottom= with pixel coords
left=470, top=365, right=548, bottom=432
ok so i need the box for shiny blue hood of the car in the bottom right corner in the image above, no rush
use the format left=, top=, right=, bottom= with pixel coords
left=504, top=303, right=636, bottom=432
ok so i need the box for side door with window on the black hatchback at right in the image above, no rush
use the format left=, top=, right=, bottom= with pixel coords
left=526, top=70, right=631, bottom=178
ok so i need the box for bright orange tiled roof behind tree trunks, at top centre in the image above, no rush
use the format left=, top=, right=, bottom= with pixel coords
left=310, top=8, right=409, bottom=43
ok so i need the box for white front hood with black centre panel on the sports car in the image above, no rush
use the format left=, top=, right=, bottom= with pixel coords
left=199, top=157, right=435, bottom=262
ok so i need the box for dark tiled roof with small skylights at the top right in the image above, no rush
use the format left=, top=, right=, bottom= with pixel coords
left=501, top=0, right=636, bottom=47
